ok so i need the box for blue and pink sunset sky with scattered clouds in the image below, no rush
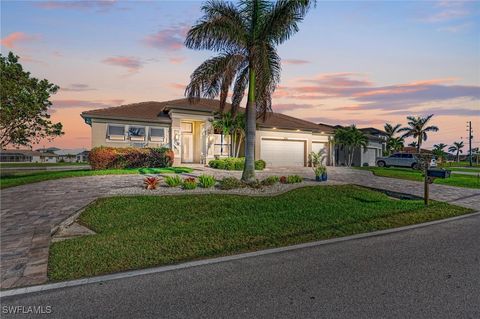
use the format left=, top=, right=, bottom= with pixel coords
left=0, top=0, right=480, bottom=148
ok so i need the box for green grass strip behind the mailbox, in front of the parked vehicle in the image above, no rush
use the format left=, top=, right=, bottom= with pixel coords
left=355, top=167, right=480, bottom=188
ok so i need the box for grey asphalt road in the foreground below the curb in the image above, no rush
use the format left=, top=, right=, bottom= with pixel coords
left=2, top=215, right=480, bottom=319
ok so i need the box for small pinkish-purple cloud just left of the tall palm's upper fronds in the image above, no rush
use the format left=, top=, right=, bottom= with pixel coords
left=144, top=25, right=188, bottom=52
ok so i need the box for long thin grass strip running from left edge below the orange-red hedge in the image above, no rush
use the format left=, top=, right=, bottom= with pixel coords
left=0, top=167, right=193, bottom=189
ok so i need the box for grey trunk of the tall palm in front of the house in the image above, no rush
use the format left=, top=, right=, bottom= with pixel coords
left=242, top=67, right=257, bottom=182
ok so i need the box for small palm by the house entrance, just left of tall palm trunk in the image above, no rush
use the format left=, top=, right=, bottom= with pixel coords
left=212, top=112, right=245, bottom=157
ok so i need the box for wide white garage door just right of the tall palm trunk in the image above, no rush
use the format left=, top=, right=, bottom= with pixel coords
left=260, top=140, right=305, bottom=167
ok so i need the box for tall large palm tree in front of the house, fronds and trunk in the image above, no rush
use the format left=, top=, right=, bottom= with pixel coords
left=185, top=0, right=313, bottom=181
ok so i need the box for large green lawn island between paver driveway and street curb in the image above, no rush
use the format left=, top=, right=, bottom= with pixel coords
left=48, top=185, right=471, bottom=280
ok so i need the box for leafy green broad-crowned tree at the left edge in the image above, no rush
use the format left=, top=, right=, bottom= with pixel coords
left=0, top=52, right=63, bottom=149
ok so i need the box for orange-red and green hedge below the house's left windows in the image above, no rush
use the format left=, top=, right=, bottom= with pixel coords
left=88, top=146, right=174, bottom=170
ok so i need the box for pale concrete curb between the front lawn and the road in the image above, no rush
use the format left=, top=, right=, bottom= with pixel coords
left=0, top=211, right=480, bottom=297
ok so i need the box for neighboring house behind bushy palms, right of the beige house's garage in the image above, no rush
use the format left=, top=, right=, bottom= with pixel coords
left=335, top=125, right=387, bottom=166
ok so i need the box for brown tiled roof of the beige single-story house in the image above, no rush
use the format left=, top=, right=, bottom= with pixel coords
left=81, top=98, right=333, bottom=133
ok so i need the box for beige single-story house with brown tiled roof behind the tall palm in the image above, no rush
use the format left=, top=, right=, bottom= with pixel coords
left=81, top=99, right=334, bottom=166
